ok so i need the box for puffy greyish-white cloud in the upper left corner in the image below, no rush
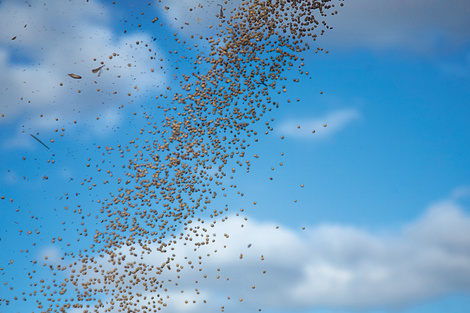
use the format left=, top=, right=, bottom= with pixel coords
left=0, top=0, right=166, bottom=141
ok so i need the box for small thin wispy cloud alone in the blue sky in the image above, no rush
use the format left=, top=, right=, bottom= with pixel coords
left=277, top=109, right=361, bottom=139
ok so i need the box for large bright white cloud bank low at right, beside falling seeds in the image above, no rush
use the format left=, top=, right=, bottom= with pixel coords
left=173, top=195, right=470, bottom=310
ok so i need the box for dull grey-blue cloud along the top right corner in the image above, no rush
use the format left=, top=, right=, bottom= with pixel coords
left=321, top=0, right=470, bottom=54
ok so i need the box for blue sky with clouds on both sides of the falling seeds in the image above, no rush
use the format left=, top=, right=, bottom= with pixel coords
left=0, top=0, right=470, bottom=313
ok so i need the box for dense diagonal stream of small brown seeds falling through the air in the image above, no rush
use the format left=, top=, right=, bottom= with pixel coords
left=0, top=0, right=346, bottom=312
